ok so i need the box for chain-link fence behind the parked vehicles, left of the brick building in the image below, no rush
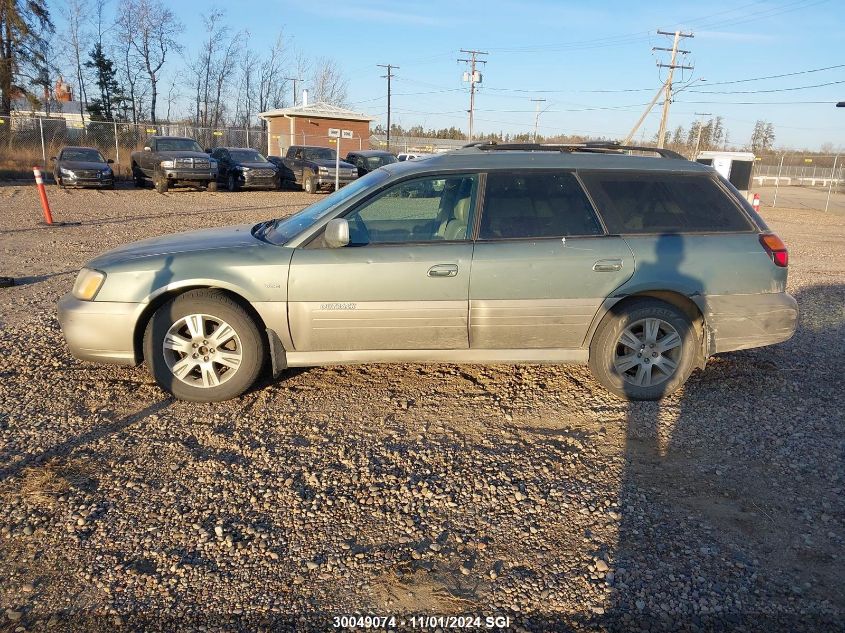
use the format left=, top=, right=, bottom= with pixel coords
left=0, top=116, right=267, bottom=177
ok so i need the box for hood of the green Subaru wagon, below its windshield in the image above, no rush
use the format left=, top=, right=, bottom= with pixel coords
left=86, top=224, right=261, bottom=269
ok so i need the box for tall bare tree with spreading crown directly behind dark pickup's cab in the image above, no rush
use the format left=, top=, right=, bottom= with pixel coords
left=123, top=0, right=184, bottom=123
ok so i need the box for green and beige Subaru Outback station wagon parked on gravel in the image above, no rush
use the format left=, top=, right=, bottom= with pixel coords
left=59, top=143, right=798, bottom=401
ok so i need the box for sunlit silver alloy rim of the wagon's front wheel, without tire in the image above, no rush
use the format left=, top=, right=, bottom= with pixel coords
left=162, top=314, right=242, bottom=389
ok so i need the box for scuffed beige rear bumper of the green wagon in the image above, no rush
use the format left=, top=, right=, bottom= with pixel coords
left=705, top=292, right=798, bottom=354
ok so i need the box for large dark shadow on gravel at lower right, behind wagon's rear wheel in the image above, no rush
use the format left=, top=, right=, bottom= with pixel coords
left=604, top=284, right=845, bottom=631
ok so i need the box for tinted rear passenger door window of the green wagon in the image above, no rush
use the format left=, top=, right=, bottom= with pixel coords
left=478, top=171, right=603, bottom=240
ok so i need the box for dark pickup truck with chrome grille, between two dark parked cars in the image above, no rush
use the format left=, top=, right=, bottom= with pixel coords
left=132, top=136, right=217, bottom=193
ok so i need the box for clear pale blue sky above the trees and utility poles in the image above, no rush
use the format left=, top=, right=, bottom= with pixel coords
left=53, top=0, right=845, bottom=149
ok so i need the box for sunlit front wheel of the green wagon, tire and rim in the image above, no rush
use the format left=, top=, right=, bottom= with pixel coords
left=144, top=289, right=267, bottom=402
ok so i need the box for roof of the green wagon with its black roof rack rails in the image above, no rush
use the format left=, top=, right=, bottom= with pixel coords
left=382, top=146, right=713, bottom=173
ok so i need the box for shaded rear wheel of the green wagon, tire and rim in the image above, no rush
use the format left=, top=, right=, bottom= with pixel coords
left=590, top=298, right=699, bottom=400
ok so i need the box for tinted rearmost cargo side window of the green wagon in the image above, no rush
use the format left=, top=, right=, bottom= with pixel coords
left=579, top=172, right=753, bottom=234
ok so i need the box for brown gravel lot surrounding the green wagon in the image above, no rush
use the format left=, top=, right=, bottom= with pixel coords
left=0, top=183, right=845, bottom=631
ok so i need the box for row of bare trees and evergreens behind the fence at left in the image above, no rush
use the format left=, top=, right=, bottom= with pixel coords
left=0, top=0, right=348, bottom=127
